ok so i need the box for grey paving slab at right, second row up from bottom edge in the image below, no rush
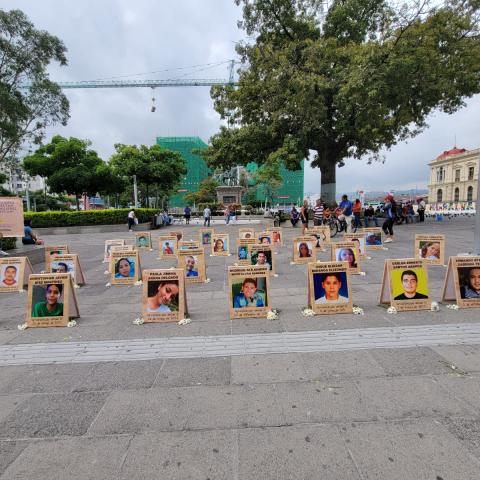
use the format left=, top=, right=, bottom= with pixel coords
left=355, top=377, right=474, bottom=419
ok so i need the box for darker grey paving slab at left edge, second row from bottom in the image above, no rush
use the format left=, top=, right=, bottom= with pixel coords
left=0, top=392, right=108, bottom=439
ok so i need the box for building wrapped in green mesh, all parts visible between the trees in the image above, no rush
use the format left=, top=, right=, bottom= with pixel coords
left=157, top=137, right=305, bottom=207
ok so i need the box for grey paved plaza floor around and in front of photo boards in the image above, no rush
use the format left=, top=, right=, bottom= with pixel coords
left=0, top=218, right=480, bottom=480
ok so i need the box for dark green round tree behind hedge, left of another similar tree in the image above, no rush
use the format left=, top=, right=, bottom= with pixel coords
left=23, top=135, right=104, bottom=209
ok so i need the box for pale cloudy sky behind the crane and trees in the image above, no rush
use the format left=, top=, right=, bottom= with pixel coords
left=4, top=0, right=480, bottom=193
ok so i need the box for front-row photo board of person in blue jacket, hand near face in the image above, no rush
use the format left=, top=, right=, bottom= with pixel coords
left=228, top=266, right=270, bottom=320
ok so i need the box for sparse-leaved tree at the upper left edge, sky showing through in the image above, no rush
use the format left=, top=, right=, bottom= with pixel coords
left=0, top=10, right=69, bottom=163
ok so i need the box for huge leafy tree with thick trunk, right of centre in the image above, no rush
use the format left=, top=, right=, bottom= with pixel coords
left=199, top=0, right=480, bottom=202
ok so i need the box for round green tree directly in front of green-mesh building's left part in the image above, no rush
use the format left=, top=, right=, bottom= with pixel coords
left=109, top=143, right=187, bottom=206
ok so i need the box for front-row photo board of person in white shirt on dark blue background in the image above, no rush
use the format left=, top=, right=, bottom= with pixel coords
left=308, top=262, right=353, bottom=315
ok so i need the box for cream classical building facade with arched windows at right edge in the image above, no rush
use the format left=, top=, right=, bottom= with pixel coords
left=428, top=147, right=480, bottom=204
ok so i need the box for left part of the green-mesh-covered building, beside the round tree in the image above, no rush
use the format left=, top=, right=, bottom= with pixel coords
left=157, top=137, right=211, bottom=207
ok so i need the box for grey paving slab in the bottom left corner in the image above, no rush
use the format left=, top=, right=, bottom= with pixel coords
left=1, top=436, right=131, bottom=480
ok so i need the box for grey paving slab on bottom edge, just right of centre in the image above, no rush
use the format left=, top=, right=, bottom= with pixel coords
left=238, top=425, right=362, bottom=480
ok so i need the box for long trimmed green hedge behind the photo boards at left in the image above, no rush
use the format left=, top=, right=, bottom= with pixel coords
left=24, top=208, right=159, bottom=228
